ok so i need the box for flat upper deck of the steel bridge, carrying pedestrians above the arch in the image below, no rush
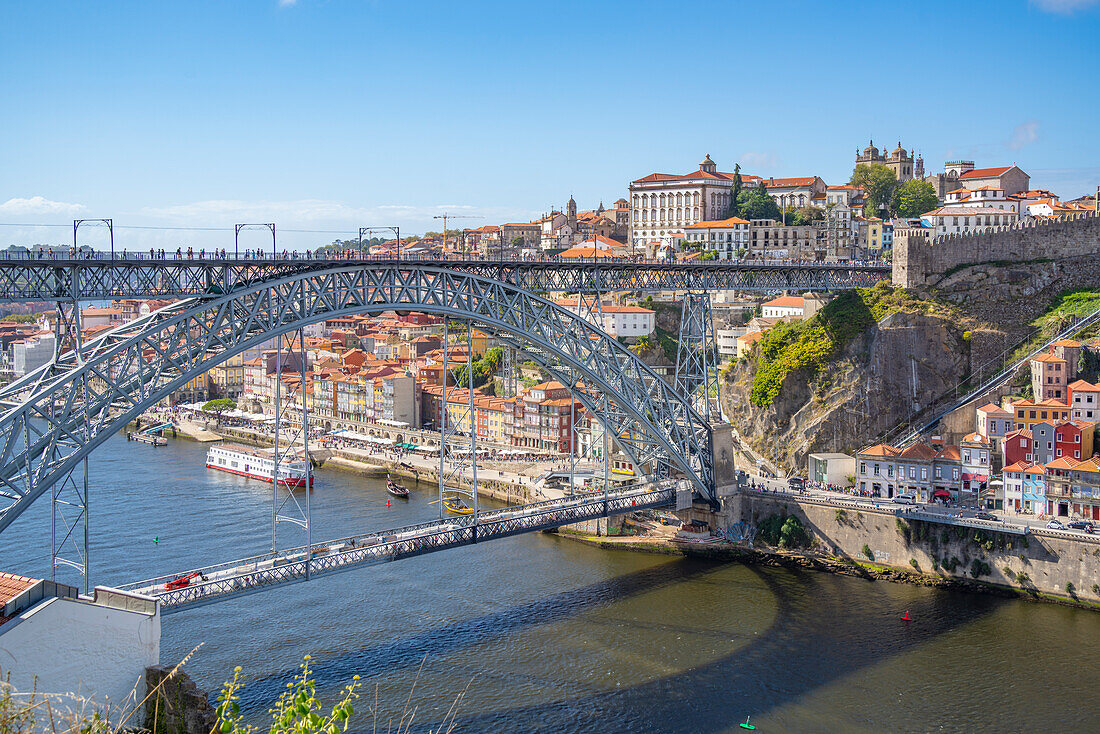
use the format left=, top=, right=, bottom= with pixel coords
left=0, top=254, right=890, bottom=303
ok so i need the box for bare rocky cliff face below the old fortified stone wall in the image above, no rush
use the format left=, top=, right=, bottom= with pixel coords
left=722, top=311, right=1003, bottom=471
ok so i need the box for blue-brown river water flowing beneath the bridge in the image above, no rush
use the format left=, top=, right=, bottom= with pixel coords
left=0, top=436, right=1100, bottom=733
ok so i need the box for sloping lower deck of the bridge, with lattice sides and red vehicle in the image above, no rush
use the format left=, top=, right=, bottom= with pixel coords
left=122, top=485, right=677, bottom=614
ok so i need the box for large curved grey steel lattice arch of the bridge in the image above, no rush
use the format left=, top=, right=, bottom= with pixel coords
left=0, top=265, right=715, bottom=539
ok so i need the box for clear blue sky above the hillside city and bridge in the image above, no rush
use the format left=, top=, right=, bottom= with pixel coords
left=0, top=0, right=1100, bottom=249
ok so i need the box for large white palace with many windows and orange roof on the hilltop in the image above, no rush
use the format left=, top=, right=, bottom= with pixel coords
left=630, top=154, right=760, bottom=248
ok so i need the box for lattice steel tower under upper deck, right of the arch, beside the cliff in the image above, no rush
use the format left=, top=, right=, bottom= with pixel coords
left=673, top=293, right=722, bottom=421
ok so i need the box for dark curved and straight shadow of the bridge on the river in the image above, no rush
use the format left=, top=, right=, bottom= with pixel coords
left=227, top=559, right=1003, bottom=732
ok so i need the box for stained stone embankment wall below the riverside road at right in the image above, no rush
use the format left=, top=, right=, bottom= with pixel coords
left=660, top=492, right=1100, bottom=610
